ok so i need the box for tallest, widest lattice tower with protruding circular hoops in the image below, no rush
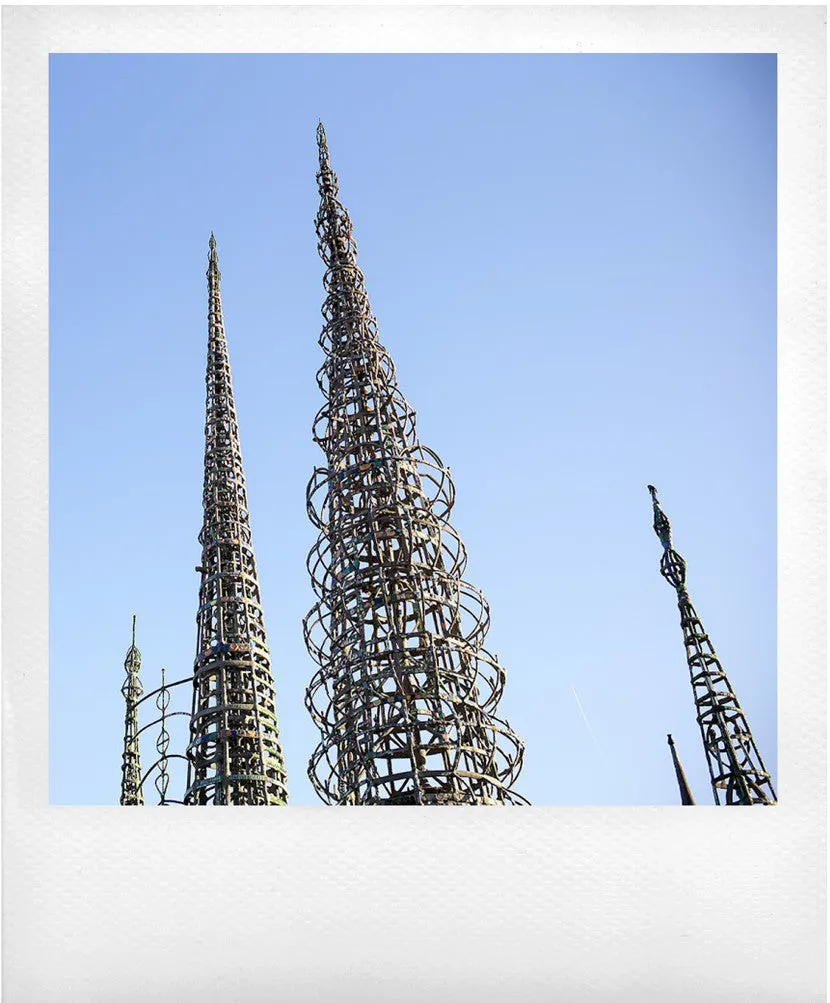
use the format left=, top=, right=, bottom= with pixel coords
left=304, top=123, right=527, bottom=805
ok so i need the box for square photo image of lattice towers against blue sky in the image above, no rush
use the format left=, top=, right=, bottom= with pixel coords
left=49, top=53, right=778, bottom=806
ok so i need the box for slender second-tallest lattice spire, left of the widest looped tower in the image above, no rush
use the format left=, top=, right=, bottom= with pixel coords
left=185, top=234, right=288, bottom=804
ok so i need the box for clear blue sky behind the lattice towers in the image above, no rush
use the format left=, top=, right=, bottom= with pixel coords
left=49, top=55, right=786, bottom=804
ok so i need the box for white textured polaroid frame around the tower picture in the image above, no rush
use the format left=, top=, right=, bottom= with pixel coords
left=2, top=6, right=826, bottom=1003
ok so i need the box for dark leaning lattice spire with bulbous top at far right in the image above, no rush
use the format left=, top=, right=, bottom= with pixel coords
left=649, top=484, right=777, bottom=804
